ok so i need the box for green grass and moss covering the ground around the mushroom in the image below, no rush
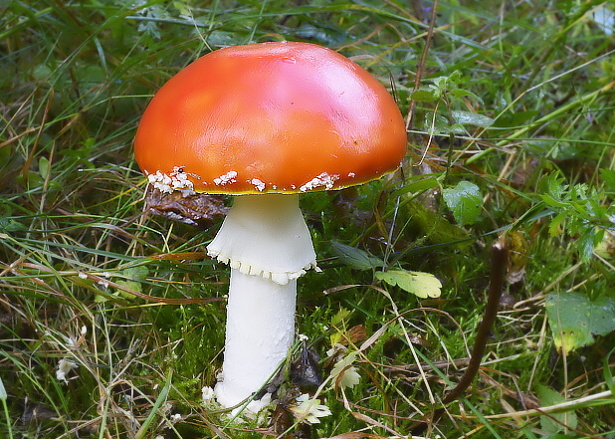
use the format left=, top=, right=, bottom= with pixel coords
left=0, top=0, right=615, bottom=439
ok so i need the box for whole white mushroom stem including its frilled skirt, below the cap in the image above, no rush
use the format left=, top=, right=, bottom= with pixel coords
left=207, top=194, right=316, bottom=412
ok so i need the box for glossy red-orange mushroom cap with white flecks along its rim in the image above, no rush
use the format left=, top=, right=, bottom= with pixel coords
left=135, top=42, right=406, bottom=194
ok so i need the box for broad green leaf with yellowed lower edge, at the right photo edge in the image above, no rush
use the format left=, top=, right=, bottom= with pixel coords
left=545, top=292, right=615, bottom=353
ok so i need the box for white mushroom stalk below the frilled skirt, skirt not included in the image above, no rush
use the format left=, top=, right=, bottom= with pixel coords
left=215, top=269, right=297, bottom=413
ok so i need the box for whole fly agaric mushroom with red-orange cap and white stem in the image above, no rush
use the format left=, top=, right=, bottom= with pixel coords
left=135, top=42, right=406, bottom=411
